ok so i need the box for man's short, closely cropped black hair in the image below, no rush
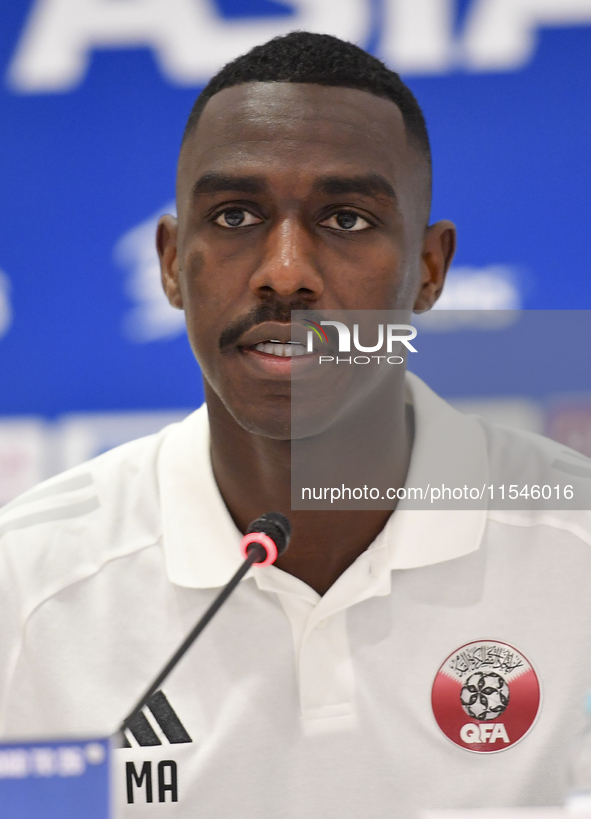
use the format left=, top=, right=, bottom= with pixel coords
left=183, top=31, right=431, bottom=168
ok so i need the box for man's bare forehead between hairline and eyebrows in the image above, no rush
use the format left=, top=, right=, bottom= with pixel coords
left=177, top=83, right=424, bottom=209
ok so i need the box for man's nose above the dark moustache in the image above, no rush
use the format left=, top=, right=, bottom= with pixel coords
left=250, top=218, right=324, bottom=302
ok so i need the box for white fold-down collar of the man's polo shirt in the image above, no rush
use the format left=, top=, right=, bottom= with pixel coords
left=158, top=373, right=488, bottom=588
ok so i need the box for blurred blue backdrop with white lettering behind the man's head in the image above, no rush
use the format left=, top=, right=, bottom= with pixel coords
left=0, top=0, right=591, bottom=418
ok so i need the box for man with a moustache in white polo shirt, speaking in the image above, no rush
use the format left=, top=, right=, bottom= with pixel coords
left=0, top=28, right=591, bottom=819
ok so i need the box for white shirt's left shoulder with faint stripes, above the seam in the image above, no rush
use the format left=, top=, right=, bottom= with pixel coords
left=0, top=416, right=195, bottom=610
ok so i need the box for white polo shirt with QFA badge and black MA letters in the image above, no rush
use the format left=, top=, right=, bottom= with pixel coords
left=0, top=376, right=591, bottom=819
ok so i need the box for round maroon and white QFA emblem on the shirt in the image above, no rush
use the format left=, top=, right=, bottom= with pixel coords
left=431, top=640, right=540, bottom=753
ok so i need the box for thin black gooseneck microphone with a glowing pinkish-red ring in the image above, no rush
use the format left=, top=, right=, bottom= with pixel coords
left=119, top=512, right=291, bottom=737
